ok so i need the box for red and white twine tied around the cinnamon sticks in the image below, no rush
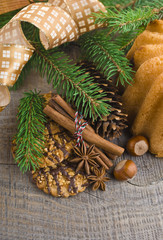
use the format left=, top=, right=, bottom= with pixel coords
left=74, top=112, right=88, bottom=147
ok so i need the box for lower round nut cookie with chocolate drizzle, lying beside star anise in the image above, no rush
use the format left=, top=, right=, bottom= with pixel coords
left=33, top=163, right=88, bottom=197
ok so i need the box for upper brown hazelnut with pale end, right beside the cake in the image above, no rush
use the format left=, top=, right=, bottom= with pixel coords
left=126, top=136, right=149, bottom=156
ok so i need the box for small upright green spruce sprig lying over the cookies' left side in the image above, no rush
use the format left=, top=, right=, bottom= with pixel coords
left=15, top=91, right=46, bottom=173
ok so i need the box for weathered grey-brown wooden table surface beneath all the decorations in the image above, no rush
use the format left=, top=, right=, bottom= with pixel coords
left=0, top=70, right=163, bottom=240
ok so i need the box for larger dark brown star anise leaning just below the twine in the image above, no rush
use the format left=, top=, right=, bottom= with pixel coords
left=70, top=143, right=99, bottom=175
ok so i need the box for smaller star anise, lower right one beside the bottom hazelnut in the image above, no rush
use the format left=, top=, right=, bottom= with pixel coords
left=87, top=167, right=110, bottom=191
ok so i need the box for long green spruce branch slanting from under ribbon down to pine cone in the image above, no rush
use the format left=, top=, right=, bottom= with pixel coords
left=30, top=43, right=109, bottom=119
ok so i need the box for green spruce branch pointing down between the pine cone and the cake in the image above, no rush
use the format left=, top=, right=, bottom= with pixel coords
left=80, top=32, right=133, bottom=85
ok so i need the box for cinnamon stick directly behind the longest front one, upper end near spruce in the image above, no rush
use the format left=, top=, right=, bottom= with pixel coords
left=52, top=95, right=95, bottom=132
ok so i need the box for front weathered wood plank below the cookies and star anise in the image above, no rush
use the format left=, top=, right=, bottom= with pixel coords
left=0, top=165, right=163, bottom=240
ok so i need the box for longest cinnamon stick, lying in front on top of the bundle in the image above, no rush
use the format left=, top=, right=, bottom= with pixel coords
left=44, top=105, right=124, bottom=156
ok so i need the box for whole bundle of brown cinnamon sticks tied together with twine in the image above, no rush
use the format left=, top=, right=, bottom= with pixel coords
left=44, top=95, right=124, bottom=169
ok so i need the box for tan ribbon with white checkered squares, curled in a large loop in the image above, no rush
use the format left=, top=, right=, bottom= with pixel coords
left=0, top=0, right=106, bottom=110
